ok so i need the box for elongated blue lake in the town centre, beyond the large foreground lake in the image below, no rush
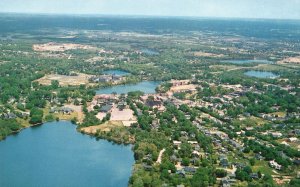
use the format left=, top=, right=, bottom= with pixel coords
left=96, top=81, right=160, bottom=94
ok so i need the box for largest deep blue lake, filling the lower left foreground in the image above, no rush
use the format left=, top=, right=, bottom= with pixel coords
left=0, top=121, right=134, bottom=187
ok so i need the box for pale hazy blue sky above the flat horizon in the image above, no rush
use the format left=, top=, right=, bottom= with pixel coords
left=0, top=0, right=300, bottom=19
